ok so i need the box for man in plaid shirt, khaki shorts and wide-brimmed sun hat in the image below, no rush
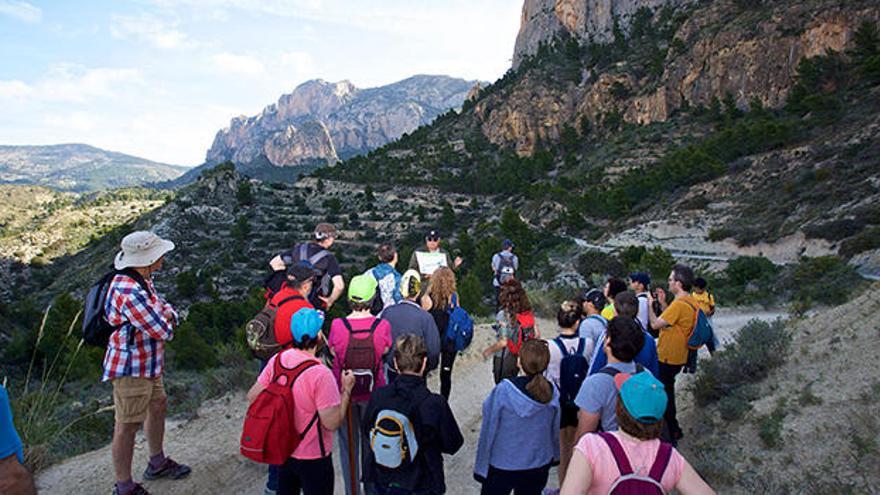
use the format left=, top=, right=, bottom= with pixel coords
left=103, top=232, right=190, bottom=495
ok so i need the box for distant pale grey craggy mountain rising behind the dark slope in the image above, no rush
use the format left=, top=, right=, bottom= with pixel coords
left=205, top=76, right=474, bottom=167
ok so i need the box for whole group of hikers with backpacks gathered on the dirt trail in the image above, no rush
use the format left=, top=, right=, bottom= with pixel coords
left=0, top=223, right=714, bottom=495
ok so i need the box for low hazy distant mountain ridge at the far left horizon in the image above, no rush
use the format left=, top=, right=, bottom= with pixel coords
left=0, top=143, right=189, bottom=192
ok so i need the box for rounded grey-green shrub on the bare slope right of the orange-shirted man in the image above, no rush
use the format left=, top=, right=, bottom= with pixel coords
left=691, top=319, right=791, bottom=406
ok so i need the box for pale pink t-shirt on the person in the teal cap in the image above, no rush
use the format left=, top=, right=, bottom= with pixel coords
left=574, top=431, right=684, bottom=495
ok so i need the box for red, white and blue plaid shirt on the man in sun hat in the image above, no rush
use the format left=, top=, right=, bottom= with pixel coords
left=103, top=274, right=177, bottom=381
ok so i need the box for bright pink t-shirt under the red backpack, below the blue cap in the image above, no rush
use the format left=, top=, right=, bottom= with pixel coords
left=257, top=349, right=341, bottom=459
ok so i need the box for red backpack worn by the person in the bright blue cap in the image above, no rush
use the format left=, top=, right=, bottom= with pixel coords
left=241, top=354, right=323, bottom=465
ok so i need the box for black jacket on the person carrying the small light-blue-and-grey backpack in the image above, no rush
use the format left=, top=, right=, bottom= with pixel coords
left=362, top=375, right=464, bottom=493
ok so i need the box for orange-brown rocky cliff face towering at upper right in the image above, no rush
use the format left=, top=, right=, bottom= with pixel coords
left=492, top=0, right=880, bottom=155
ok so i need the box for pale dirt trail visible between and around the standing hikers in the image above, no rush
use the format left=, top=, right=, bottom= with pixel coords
left=38, top=310, right=782, bottom=495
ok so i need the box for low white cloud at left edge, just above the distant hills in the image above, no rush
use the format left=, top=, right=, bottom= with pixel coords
left=0, top=64, right=143, bottom=103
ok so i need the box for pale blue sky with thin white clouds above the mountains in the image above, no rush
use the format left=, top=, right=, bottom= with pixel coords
left=0, top=0, right=522, bottom=165
